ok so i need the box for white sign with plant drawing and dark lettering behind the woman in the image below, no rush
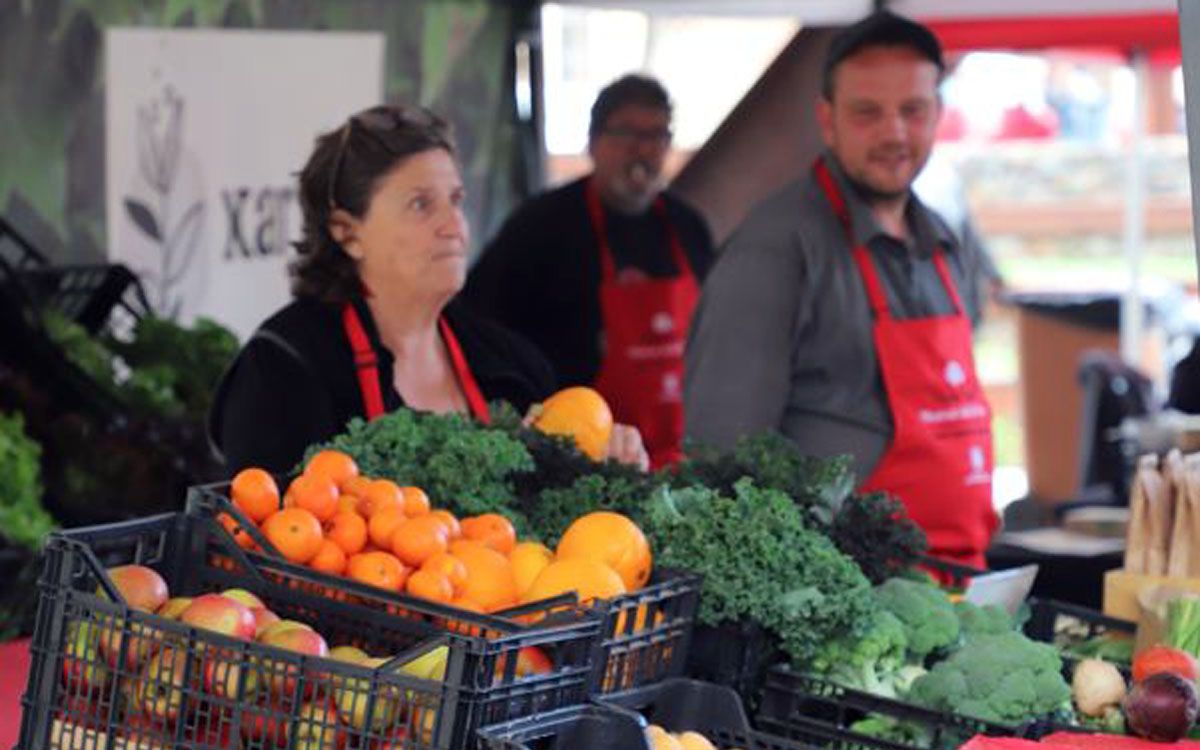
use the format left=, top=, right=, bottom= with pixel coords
left=104, top=29, right=384, bottom=340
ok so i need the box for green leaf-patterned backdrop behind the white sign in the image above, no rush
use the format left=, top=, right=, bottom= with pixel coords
left=0, top=0, right=523, bottom=263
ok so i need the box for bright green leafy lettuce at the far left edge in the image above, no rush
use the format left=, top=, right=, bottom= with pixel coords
left=0, top=413, right=55, bottom=550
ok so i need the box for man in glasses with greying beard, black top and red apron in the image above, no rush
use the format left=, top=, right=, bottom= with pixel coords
left=466, top=76, right=713, bottom=467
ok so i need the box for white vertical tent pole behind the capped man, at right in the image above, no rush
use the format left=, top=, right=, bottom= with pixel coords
left=1121, top=49, right=1147, bottom=366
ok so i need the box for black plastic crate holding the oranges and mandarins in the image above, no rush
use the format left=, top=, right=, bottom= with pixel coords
left=187, top=482, right=701, bottom=694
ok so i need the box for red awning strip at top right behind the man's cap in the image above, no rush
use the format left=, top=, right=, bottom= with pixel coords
left=922, top=13, right=1180, bottom=65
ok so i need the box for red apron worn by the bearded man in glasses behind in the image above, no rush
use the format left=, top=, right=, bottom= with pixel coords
left=586, top=181, right=700, bottom=468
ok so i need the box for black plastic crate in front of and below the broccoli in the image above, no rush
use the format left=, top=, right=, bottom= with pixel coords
left=758, top=666, right=1025, bottom=750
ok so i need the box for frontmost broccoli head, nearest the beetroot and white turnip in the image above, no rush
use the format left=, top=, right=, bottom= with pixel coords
left=908, top=631, right=1070, bottom=725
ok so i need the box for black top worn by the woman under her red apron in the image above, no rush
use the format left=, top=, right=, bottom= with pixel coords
left=209, top=299, right=554, bottom=474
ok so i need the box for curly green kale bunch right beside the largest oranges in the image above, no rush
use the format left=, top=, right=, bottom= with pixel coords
left=643, top=480, right=872, bottom=664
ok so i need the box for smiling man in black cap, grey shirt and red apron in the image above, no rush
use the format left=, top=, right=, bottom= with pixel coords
left=685, top=12, right=996, bottom=566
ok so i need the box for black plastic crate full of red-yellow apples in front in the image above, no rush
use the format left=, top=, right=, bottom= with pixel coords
left=17, top=514, right=600, bottom=750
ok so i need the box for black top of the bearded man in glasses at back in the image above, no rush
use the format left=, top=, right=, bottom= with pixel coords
left=463, top=178, right=713, bottom=388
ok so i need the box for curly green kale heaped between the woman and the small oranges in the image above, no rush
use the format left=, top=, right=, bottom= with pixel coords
left=309, top=409, right=534, bottom=525
